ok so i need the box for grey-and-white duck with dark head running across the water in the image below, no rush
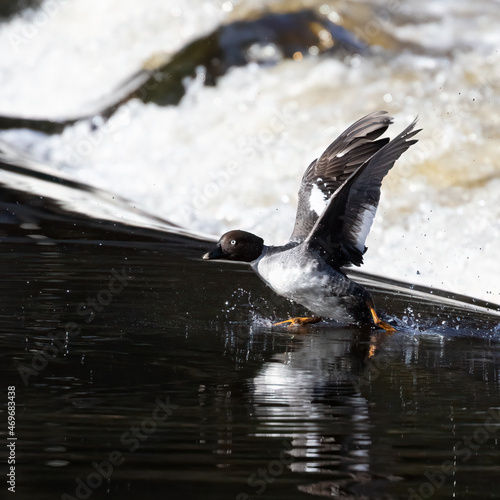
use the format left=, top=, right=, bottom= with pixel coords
left=203, top=111, right=420, bottom=331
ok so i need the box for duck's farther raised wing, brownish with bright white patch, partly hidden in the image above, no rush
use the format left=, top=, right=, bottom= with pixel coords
left=290, top=111, right=392, bottom=241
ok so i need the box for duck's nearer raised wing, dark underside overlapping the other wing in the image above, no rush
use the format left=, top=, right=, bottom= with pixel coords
left=306, top=119, right=420, bottom=268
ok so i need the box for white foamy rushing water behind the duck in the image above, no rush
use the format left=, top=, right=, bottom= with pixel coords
left=0, top=0, right=500, bottom=303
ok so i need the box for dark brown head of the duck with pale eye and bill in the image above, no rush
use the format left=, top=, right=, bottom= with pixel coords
left=203, top=229, right=264, bottom=262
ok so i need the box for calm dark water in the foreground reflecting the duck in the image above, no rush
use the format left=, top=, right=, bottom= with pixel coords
left=0, top=185, right=500, bottom=500
